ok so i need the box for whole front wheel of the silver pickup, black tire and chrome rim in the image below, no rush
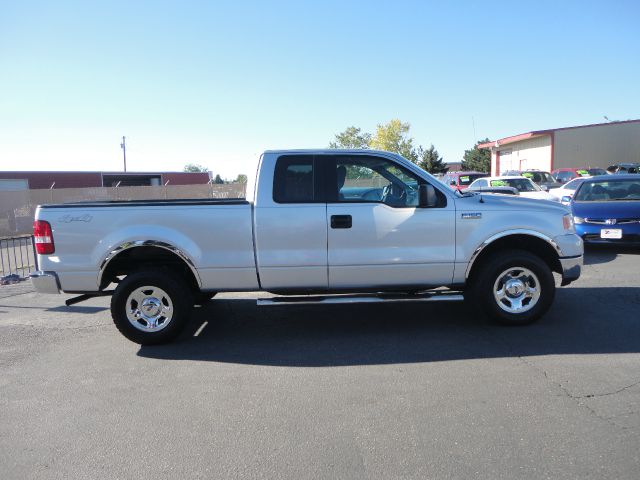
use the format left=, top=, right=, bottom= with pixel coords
left=470, top=250, right=556, bottom=325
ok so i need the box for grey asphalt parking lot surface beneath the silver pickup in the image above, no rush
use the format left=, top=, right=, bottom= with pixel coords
left=0, top=249, right=640, bottom=479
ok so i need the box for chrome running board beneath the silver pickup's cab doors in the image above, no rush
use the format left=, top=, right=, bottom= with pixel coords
left=257, top=291, right=464, bottom=306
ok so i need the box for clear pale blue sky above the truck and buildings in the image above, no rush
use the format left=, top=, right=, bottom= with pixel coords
left=0, top=0, right=640, bottom=178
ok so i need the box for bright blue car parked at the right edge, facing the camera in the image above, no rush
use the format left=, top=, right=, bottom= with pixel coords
left=562, top=175, right=640, bottom=245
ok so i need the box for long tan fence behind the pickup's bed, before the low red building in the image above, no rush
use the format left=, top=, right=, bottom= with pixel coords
left=0, top=183, right=246, bottom=239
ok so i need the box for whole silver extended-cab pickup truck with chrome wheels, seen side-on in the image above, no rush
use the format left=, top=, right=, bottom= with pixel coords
left=32, top=150, right=583, bottom=344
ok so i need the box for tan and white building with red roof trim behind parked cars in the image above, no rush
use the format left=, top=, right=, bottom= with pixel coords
left=478, top=120, right=640, bottom=175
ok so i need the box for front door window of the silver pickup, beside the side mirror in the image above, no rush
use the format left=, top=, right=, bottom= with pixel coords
left=336, top=155, right=419, bottom=208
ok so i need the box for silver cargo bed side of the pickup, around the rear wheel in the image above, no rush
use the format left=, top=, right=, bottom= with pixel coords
left=37, top=199, right=258, bottom=292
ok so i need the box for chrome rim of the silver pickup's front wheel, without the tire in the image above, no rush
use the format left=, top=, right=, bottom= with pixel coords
left=493, top=267, right=541, bottom=314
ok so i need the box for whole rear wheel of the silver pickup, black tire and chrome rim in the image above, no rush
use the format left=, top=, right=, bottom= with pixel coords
left=111, top=270, right=193, bottom=345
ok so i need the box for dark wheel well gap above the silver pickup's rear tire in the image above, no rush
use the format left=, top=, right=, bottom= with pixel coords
left=100, top=246, right=200, bottom=291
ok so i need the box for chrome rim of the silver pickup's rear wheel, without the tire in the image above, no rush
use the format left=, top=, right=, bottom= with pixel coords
left=125, top=285, right=173, bottom=332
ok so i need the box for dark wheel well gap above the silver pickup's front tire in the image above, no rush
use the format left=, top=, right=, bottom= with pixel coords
left=468, top=234, right=562, bottom=280
